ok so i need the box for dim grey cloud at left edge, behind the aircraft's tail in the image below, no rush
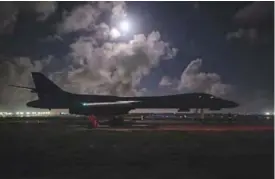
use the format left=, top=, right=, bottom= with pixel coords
left=0, top=57, right=50, bottom=107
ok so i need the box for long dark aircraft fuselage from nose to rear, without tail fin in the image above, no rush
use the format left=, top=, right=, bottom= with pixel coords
left=27, top=93, right=237, bottom=114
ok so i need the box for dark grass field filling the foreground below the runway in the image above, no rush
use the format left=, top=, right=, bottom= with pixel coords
left=0, top=123, right=274, bottom=179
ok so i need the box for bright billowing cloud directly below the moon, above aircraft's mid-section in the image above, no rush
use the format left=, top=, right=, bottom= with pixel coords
left=59, top=31, right=177, bottom=95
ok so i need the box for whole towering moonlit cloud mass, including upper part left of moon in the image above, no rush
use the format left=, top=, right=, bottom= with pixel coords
left=49, top=2, right=177, bottom=96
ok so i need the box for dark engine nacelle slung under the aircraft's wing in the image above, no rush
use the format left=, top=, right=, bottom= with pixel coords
left=69, top=106, right=132, bottom=116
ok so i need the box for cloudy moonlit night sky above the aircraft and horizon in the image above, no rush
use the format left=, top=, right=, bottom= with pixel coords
left=0, top=2, right=274, bottom=113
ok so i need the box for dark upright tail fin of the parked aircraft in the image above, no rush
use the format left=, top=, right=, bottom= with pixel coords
left=32, top=72, right=64, bottom=98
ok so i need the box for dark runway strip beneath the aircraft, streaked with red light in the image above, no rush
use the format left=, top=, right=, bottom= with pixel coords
left=1, top=120, right=274, bottom=132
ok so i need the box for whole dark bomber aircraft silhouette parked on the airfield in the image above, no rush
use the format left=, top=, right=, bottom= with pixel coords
left=10, top=72, right=238, bottom=127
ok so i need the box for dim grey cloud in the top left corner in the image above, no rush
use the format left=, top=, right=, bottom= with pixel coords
left=0, top=1, right=57, bottom=34
